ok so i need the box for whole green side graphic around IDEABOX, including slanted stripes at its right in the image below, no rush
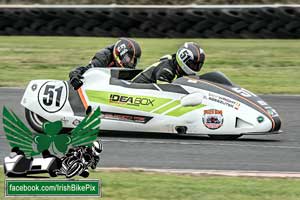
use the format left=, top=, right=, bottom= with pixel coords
left=85, top=90, right=205, bottom=117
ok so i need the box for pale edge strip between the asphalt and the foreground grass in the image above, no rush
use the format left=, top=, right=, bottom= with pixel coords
left=96, top=167, right=300, bottom=178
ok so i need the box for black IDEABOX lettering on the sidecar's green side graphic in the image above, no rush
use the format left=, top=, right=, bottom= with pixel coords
left=109, top=94, right=155, bottom=106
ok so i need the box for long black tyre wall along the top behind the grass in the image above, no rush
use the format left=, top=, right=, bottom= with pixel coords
left=0, top=5, right=300, bottom=38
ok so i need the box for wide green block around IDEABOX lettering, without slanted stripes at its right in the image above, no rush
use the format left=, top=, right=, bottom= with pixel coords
left=85, top=90, right=173, bottom=112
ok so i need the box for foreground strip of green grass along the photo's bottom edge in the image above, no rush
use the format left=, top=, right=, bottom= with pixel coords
left=0, top=172, right=300, bottom=200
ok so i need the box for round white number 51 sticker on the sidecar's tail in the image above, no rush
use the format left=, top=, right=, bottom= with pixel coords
left=38, top=81, right=68, bottom=113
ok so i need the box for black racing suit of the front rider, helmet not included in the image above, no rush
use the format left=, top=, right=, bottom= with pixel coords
left=132, top=54, right=186, bottom=83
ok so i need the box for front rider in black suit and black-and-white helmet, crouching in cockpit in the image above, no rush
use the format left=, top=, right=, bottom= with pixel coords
left=132, top=42, right=205, bottom=83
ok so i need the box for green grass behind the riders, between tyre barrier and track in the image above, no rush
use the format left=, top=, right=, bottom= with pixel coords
left=0, top=36, right=300, bottom=94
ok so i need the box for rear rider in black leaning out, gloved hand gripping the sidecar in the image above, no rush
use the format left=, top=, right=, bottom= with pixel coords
left=69, top=38, right=142, bottom=90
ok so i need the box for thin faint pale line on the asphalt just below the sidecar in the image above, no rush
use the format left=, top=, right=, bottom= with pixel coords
left=102, top=139, right=300, bottom=149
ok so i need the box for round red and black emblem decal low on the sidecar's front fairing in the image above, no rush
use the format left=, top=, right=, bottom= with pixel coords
left=202, top=109, right=224, bottom=130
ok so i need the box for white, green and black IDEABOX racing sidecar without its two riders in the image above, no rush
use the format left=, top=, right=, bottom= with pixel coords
left=21, top=68, right=281, bottom=139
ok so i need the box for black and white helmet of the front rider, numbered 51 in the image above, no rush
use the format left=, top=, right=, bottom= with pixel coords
left=176, top=42, right=205, bottom=75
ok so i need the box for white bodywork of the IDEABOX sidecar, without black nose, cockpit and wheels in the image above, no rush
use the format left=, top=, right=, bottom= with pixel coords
left=21, top=68, right=278, bottom=135
